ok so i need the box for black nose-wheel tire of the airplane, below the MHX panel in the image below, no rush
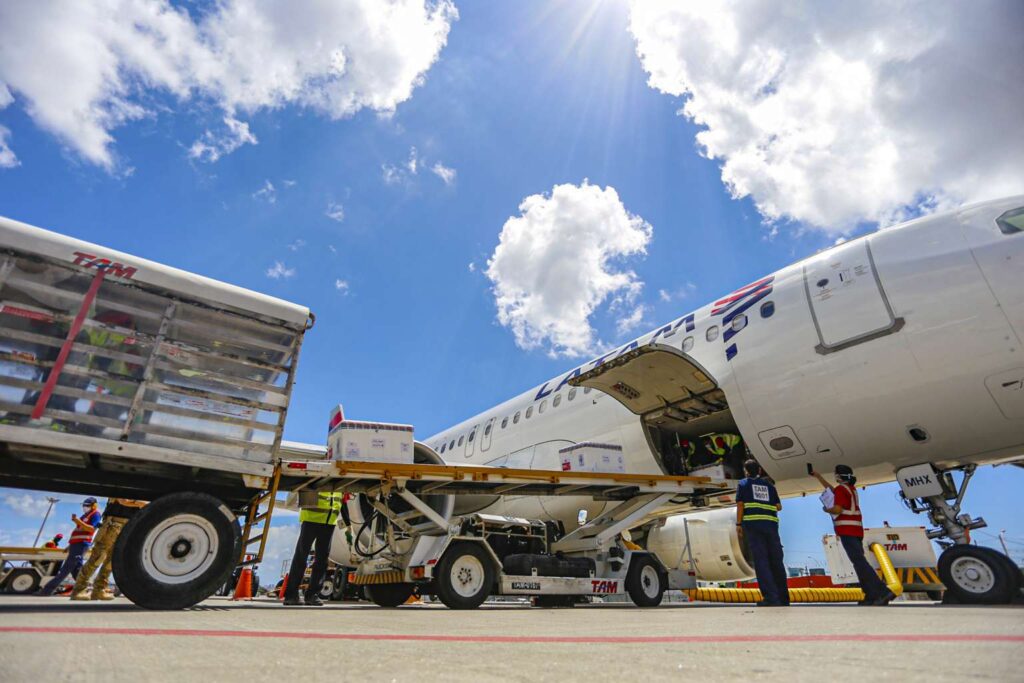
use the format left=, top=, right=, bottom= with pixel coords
left=939, top=545, right=1020, bottom=605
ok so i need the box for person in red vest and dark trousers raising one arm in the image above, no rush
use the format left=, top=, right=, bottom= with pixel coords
left=811, top=465, right=896, bottom=607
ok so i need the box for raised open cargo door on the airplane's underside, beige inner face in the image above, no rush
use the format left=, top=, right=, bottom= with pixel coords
left=569, top=344, right=729, bottom=423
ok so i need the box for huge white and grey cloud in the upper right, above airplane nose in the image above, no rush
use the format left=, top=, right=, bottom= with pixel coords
left=630, top=0, right=1024, bottom=234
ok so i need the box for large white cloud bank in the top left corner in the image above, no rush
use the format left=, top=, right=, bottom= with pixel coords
left=0, top=0, right=458, bottom=169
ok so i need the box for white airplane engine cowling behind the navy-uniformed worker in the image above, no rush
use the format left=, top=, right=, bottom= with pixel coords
left=647, top=508, right=754, bottom=581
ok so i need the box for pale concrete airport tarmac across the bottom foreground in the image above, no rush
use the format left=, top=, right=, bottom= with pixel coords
left=0, top=596, right=1024, bottom=683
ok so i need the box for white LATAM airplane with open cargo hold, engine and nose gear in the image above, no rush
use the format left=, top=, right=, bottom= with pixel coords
left=332, top=196, right=1024, bottom=601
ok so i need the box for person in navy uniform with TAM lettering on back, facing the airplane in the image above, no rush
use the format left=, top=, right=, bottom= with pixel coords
left=736, top=460, right=790, bottom=607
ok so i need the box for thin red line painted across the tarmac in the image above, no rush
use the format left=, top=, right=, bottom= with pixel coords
left=0, top=626, right=1024, bottom=644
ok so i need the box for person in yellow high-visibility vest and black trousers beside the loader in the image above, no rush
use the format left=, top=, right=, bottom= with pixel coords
left=284, top=493, right=348, bottom=607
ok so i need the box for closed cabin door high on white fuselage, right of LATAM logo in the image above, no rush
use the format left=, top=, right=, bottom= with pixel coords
left=804, top=239, right=903, bottom=354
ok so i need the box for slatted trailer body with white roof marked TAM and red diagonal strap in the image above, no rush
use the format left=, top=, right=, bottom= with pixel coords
left=0, top=218, right=311, bottom=463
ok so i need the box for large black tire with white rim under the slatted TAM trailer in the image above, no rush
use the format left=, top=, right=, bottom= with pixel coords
left=114, top=493, right=242, bottom=609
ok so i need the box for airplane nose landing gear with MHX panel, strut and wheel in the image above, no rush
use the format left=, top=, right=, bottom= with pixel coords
left=896, top=463, right=1021, bottom=604
